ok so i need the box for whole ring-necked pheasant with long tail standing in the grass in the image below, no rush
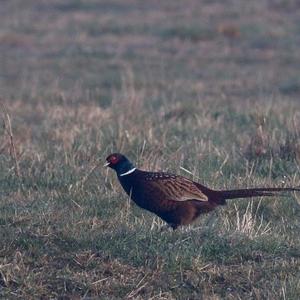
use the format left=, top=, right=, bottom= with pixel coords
left=104, top=153, right=300, bottom=230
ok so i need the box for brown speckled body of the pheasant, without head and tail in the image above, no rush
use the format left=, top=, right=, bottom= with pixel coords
left=118, top=170, right=226, bottom=229
